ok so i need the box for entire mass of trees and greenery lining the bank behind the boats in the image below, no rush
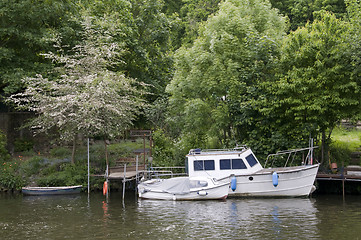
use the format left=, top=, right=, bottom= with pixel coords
left=0, top=0, right=361, bottom=195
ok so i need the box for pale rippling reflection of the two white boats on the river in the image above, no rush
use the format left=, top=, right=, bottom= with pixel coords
left=138, top=199, right=318, bottom=239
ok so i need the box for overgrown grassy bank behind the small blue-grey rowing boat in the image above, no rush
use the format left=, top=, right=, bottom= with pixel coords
left=0, top=140, right=149, bottom=191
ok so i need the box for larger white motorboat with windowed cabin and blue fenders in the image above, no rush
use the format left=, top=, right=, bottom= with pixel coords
left=186, top=147, right=319, bottom=197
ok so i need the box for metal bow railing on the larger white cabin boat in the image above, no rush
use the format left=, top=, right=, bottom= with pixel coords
left=264, top=146, right=318, bottom=168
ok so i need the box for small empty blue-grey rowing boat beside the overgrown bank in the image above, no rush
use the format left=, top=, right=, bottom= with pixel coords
left=22, top=185, right=82, bottom=195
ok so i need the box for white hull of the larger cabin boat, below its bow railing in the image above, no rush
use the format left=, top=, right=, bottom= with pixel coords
left=228, top=164, right=319, bottom=197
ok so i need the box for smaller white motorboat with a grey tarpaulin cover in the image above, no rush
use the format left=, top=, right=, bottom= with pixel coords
left=138, top=177, right=229, bottom=200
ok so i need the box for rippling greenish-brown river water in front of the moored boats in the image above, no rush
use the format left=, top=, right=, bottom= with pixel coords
left=0, top=192, right=361, bottom=240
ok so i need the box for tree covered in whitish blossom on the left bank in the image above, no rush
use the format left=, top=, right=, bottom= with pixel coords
left=9, top=17, right=146, bottom=162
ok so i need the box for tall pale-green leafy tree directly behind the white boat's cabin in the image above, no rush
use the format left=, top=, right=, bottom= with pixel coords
left=167, top=0, right=285, bottom=150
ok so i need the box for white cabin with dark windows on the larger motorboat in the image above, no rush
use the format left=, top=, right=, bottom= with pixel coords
left=186, top=147, right=263, bottom=179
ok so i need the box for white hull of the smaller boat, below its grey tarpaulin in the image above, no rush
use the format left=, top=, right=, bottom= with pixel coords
left=138, top=179, right=229, bottom=200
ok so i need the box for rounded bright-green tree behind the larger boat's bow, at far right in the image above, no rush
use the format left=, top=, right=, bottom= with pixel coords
left=269, top=11, right=360, bottom=163
